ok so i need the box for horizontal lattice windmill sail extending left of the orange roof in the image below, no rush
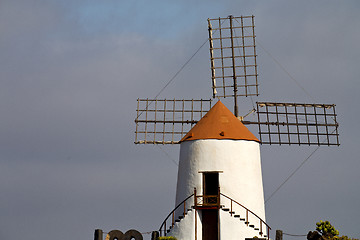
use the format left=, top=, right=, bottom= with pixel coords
left=135, top=98, right=212, bottom=144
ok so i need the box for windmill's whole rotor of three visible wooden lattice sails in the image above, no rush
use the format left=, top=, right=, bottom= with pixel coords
left=135, top=16, right=340, bottom=146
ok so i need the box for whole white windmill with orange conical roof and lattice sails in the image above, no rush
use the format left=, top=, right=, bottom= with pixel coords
left=135, top=16, right=339, bottom=240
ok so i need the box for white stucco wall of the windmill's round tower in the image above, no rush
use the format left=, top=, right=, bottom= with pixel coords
left=173, top=139, right=265, bottom=240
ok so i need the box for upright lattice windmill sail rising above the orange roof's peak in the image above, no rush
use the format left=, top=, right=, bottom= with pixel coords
left=208, top=15, right=259, bottom=101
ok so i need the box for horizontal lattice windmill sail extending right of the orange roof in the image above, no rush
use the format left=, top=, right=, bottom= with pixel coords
left=243, top=102, right=340, bottom=146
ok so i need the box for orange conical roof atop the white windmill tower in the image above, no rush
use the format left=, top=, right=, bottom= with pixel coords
left=180, top=101, right=260, bottom=142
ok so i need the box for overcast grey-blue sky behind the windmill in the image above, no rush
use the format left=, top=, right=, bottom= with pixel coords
left=0, top=0, right=360, bottom=240
